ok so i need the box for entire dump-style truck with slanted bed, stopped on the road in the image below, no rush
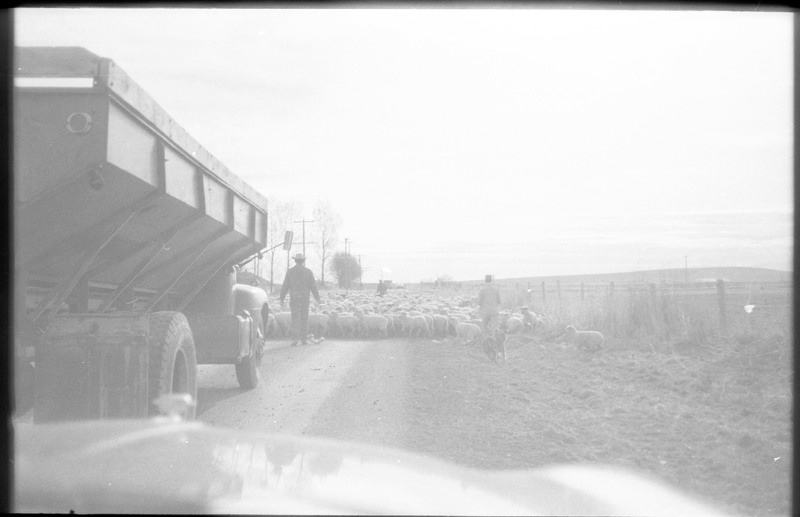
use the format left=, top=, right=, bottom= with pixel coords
left=12, top=47, right=276, bottom=423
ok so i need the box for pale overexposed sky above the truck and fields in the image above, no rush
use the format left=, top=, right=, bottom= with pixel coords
left=14, top=3, right=794, bottom=282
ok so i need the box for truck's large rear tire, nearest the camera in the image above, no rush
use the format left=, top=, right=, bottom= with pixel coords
left=148, top=311, right=197, bottom=420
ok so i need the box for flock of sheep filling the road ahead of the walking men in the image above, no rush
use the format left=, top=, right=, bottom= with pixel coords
left=267, top=289, right=604, bottom=350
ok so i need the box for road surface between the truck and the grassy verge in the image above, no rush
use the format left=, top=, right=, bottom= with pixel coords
left=197, top=340, right=410, bottom=446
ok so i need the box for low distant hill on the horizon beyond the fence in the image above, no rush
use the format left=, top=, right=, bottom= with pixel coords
left=462, top=267, right=792, bottom=284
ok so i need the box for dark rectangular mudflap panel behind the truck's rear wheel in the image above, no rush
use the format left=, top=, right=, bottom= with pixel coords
left=33, top=314, right=149, bottom=423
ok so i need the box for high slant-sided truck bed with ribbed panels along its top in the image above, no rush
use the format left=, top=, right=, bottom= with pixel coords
left=13, top=47, right=267, bottom=319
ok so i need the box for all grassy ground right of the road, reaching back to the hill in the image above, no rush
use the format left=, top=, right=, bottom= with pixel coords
left=382, top=283, right=794, bottom=515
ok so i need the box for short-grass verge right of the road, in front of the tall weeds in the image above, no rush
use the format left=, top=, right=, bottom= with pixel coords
left=406, top=330, right=792, bottom=515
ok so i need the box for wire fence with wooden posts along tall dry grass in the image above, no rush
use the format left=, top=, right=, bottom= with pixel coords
left=419, top=280, right=792, bottom=343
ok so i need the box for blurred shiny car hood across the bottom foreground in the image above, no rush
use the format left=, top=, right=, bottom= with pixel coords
left=14, top=419, right=722, bottom=515
